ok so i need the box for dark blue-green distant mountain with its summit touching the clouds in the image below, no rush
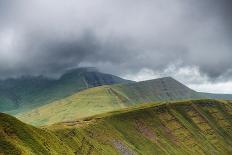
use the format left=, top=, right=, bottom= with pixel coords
left=0, top=68, right=131, bottom=113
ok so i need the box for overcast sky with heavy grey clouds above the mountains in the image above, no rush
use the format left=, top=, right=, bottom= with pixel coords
left=0, top=0, right=232, bottom=93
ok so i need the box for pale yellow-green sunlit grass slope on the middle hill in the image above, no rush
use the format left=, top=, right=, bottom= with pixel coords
left=17, top=86, right=129, bottom=125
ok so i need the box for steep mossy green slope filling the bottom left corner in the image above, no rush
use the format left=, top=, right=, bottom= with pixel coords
left=0, top=113, right=73, bottom=155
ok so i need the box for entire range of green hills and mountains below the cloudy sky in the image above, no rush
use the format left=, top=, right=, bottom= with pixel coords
left=0, top=68, right=232, bottom=155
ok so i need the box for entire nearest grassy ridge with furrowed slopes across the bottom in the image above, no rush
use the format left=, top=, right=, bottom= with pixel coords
left=0, top=100, right=232, bottom=155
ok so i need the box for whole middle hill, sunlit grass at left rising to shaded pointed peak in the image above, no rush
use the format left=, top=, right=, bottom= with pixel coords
left=16, top=77, right=203, bottom=125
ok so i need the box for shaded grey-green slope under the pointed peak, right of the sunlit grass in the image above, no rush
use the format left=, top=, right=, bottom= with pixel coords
left=112, top=77, right=202, bottom=103
